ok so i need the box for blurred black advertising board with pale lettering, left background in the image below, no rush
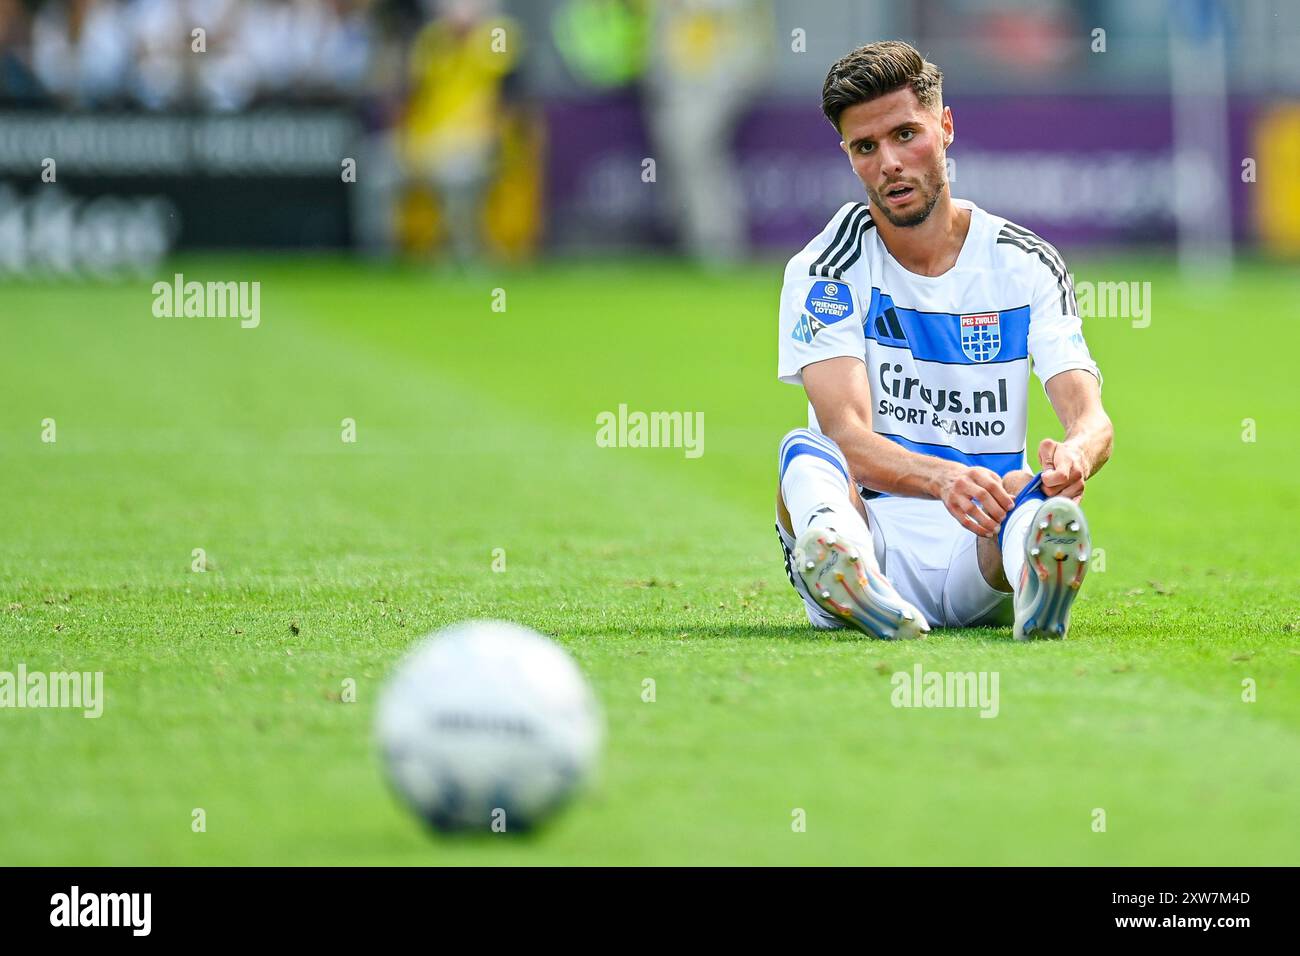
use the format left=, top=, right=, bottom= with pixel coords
left=0, top=109, right=358, bottom=274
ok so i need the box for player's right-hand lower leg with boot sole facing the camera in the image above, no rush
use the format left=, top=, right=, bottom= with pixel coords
left=976, top=472, right=1092, bottom=640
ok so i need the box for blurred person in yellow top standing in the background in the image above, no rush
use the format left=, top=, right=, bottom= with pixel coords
left=398, top=0, right=540, bottom=263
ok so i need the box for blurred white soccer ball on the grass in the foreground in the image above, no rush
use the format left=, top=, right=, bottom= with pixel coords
left=378, top=620, right=602, bottom=832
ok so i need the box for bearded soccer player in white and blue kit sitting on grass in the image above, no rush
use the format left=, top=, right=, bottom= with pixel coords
left=776, top=40, right=1112, bottom=640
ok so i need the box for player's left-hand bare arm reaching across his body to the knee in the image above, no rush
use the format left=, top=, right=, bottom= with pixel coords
left=802, top=356, right=1013, bottom=537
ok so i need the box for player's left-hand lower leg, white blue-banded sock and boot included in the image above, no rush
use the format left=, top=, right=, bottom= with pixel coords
left=776, top=428, right=930, bottom=640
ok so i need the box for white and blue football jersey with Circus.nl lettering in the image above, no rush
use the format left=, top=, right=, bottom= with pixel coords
left=777, top=199, right=1101, bottom=475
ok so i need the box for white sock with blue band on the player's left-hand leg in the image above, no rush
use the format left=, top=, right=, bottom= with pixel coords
left=781, top=428, right=880, bottom=571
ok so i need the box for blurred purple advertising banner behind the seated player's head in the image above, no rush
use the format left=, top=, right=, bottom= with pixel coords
left=546, top=95, right=1255, bottom=255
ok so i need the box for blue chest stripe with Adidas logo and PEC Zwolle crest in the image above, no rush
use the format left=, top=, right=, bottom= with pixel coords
left=862, top=287, right=1030, bottom=365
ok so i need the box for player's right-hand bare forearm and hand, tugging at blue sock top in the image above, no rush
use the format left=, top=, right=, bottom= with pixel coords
left=1039, top=368, right=1114, bottom=501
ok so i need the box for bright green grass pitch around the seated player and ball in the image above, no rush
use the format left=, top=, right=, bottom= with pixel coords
left=0, top=258, right=1300, bottom=865
